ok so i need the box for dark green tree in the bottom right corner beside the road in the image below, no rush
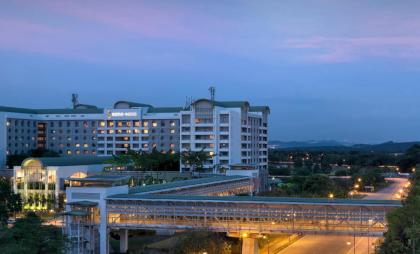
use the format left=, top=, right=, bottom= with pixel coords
left=380, top=169, right=420, bottom=254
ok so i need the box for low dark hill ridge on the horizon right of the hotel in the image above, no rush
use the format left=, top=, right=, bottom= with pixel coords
left=269, top=140, right=420, bottom=153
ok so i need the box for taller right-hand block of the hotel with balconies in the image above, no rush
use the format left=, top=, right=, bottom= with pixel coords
left=180, top=99, right=269, bottom=171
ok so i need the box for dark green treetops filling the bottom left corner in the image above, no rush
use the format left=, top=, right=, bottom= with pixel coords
left=0, top=213, right=63, bottom=254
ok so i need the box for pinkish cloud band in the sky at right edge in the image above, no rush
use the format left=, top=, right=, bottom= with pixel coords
left=280, top=36, right=420, bottom=63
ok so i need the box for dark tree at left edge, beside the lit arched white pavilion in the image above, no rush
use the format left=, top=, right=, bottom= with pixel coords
left=0, top=177, right=22, bottom=226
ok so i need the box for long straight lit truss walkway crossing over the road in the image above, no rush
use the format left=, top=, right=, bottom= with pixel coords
left=107, top=194, right=401, bottom=236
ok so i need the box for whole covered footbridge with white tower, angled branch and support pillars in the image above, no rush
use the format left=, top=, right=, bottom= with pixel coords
left=65, top=176, right=401, bottom=254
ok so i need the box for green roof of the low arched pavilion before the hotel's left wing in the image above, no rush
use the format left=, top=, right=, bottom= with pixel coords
left=27, top=155, right=112, bottom=167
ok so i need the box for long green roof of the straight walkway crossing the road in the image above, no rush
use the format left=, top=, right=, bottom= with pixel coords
left=108, top=194, right=402, bottom=207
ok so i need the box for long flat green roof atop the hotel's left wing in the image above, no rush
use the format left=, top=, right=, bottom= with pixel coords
left=0, top=106, right=104, bottom=114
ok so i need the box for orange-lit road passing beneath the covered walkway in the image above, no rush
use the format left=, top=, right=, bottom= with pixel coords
left=273, top=178, right=408, bottom=254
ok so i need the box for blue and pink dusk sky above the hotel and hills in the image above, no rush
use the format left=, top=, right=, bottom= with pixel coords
left=0, top=0, right=420, bottom=143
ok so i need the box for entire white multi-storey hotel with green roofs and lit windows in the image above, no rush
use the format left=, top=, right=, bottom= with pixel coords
left=0, top=99, right=269, bottom=174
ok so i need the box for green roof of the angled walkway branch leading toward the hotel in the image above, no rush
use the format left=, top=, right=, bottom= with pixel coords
left=130, top=176, right=248, bottom=194
